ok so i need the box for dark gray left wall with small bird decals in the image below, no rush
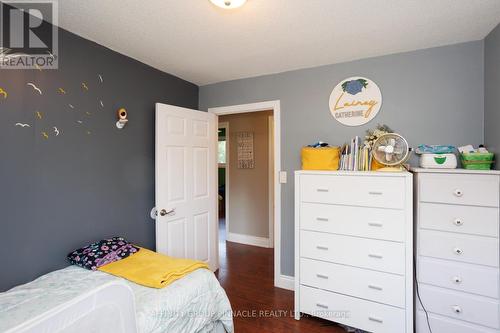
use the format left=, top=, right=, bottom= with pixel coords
left=0, top=27, right=198, bottom=291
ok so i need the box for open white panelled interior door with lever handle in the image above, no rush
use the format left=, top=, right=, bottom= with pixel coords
left=156, top=103, right=219, bottom=270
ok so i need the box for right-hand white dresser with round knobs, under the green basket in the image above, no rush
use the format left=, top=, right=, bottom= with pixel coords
left=413, top=169, right=500, bottom=333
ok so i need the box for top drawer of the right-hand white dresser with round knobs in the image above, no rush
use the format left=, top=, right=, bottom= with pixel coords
left=419, top=174, right=500, bottom=207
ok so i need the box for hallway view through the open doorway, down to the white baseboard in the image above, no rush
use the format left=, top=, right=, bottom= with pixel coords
left=218, top=110, right=274, bottom=248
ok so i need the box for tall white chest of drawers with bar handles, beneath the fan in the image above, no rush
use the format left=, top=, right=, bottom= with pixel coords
left=295, top=171, right=413, bottom=333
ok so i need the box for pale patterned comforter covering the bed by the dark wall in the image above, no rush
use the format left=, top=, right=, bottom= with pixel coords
left=0, top=266, right=233, bottom=333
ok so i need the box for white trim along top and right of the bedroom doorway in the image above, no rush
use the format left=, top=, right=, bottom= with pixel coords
left=208, top=100, right=286, bottom=289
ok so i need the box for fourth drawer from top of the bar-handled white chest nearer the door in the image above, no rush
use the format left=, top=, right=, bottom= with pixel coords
left=300, top=258, right=405, bottom=308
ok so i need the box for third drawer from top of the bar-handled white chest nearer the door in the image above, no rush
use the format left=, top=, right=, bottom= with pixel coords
left=300, top=230, right=405, bottom=275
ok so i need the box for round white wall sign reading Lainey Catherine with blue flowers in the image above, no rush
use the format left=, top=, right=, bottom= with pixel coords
left=330, top=76, right=382, bottom=126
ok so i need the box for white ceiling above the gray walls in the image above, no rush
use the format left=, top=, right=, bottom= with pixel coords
left=54, top=0, right=500, bottom=85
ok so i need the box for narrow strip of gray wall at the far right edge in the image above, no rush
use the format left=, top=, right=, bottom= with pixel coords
left=484, top=25, right=500, bottom=169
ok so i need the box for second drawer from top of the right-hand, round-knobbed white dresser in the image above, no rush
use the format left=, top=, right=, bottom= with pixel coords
left=419, top=202, right=499, bottom=237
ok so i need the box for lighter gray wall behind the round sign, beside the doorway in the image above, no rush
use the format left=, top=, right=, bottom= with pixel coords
left=200, top=41, right=484, bottom=275
